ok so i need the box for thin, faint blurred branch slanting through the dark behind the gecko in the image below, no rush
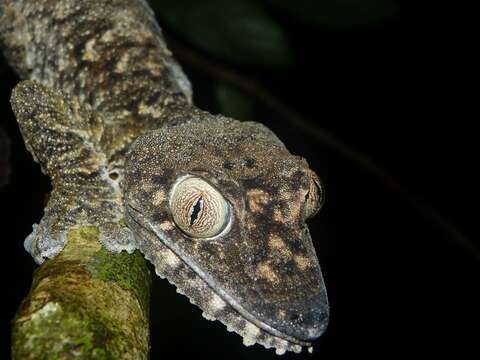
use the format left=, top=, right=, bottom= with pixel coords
left=168, top=38, right=480, bottom=260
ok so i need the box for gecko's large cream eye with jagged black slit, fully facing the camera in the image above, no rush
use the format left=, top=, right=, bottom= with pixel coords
left=170, top=177, right=230, bottom=238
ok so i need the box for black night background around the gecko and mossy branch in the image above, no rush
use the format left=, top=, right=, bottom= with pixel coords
left=0, top=0, right=480, bottom=359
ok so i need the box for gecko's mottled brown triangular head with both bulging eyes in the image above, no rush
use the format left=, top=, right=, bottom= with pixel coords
left=124, top=115, right=329, bottom=352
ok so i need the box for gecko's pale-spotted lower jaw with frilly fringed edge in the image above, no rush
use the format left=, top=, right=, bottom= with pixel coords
left=126, top=205, right=323, bottom=354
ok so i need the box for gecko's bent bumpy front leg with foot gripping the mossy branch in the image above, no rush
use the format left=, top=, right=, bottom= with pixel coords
left=11, top=81, right=134, bottom=263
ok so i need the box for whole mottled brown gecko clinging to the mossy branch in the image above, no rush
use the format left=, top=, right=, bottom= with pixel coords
left=0, top=0, right=329, bottom=354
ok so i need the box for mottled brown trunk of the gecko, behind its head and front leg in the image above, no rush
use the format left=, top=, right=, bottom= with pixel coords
left=0, top=0, right=191, bottom=165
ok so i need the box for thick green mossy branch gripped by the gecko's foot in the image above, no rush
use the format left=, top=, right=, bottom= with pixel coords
left=12, top=227, right=151, bottom=359
